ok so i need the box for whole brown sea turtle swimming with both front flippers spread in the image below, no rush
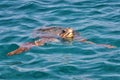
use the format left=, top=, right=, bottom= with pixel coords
left=8, top=27, right=115, bottom=56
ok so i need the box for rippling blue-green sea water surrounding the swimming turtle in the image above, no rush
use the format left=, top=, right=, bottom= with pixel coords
left=0, top=0, right=120, bottom=80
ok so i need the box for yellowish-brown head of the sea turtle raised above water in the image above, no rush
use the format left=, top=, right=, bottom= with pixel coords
left=60, top=28, right=74, bottom=39
